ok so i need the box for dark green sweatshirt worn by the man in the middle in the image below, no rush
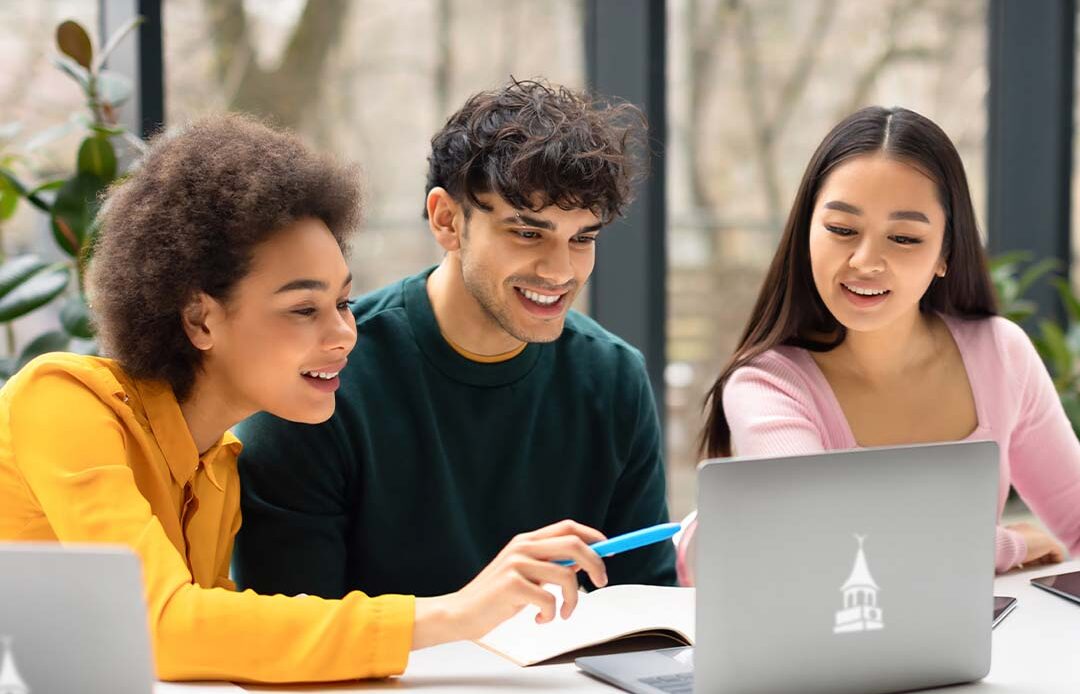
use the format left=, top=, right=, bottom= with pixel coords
left=233, top=270, right=675, bottom=598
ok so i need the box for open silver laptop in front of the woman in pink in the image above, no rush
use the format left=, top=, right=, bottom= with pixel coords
left=577, top=441, right=999, bottom=694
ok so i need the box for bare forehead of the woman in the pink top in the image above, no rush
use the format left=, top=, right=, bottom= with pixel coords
left=815, top=154, right=944, bottom=216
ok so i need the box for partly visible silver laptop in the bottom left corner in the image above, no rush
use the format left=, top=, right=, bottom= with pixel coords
left=0, top=543, right=153, bottom=694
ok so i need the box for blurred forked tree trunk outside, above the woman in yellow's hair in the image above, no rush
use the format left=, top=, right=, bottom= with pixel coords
left=204, top=0, right=349, bottom=127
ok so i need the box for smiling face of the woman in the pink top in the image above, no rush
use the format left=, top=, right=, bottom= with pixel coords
left=810, top=154, right=946, bottom=331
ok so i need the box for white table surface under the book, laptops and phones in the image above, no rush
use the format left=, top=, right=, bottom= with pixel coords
left=154, top=560, right=1080, bottom=694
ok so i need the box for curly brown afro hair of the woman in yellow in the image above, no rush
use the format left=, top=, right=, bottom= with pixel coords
left=87, top=114, right=361, bottom=400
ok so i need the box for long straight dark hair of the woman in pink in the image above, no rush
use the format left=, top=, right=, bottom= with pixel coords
left=700, top=106, right=997, bottom=458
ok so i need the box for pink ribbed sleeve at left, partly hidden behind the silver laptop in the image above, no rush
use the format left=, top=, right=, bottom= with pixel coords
left=675, top=359, right=825, bottom=586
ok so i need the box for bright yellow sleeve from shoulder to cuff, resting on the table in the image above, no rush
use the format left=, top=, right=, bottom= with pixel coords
left=11, top=375, right=415, bottom=682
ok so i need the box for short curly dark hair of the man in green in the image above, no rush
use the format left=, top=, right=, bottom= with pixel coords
left=424, top=80, right=647, bottom=223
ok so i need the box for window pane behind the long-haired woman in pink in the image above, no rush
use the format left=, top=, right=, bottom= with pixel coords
left=666, top=0, right=987, bottom=516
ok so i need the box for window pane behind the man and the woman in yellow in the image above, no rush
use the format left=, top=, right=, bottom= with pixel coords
left=163, top=0, right=585, bottom=294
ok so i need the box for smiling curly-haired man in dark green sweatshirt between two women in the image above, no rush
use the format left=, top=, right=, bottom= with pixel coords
left=235, top=81, right=675, bottom=597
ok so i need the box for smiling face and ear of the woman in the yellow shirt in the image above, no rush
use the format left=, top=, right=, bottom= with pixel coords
left=192, top=218, right=356, bottom=424
